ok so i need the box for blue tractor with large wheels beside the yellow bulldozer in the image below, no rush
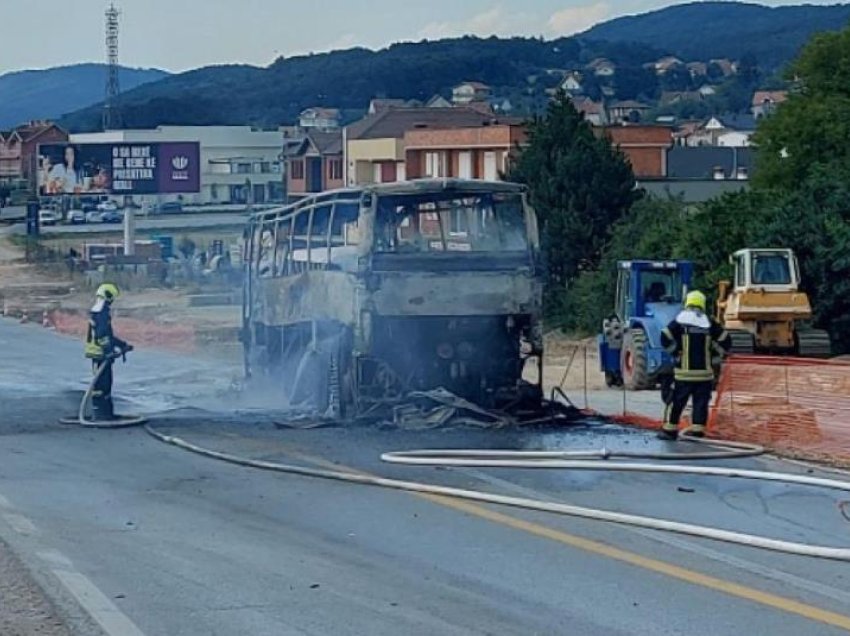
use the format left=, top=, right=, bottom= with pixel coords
left=598, top=261, right=694, bottom=391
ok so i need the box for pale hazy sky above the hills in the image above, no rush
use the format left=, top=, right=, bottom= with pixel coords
left=0, top=0, right=835, bottom=74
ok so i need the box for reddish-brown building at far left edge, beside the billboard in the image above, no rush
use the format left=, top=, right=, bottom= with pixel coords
left=0, top=120, right=68, bottom=189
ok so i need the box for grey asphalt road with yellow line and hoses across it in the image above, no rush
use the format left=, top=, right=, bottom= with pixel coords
left=0, top=321, right=850, bottom=636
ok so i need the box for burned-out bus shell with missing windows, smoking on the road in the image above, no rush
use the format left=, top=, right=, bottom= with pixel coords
left=242, top=179, right=543, bottom=417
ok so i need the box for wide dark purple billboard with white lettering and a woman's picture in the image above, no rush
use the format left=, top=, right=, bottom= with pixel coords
left=38, top=142, right=201, bottom=196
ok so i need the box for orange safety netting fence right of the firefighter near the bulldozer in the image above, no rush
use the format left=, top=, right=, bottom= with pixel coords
left=709, top=356, right=850, bottom=464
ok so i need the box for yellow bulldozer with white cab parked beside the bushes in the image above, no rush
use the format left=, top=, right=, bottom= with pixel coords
left=717, top=249, right=831, bottom=358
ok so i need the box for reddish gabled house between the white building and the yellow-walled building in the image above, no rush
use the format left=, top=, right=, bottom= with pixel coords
left=283, top=128, right=345, bottom=201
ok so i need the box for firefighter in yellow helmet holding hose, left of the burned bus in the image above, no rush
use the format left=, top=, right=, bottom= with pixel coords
left=85, top=283, right=133, bottom=421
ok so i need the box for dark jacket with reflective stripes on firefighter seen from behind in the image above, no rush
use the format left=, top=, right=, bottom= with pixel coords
left=661, top=309, right=731, bottom=382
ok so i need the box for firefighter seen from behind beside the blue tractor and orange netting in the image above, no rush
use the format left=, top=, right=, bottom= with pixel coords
left=658, top=291, right=731, bottom=440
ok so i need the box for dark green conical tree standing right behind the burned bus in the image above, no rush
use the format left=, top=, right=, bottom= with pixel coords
left=509, top=92, right=639, bottom=313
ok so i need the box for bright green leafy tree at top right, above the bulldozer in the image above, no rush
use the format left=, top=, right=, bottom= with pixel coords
left=754, top=29, right=850, bottom=189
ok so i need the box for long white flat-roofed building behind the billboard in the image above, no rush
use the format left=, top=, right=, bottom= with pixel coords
left=70, top=126, right=283, bottom=205
